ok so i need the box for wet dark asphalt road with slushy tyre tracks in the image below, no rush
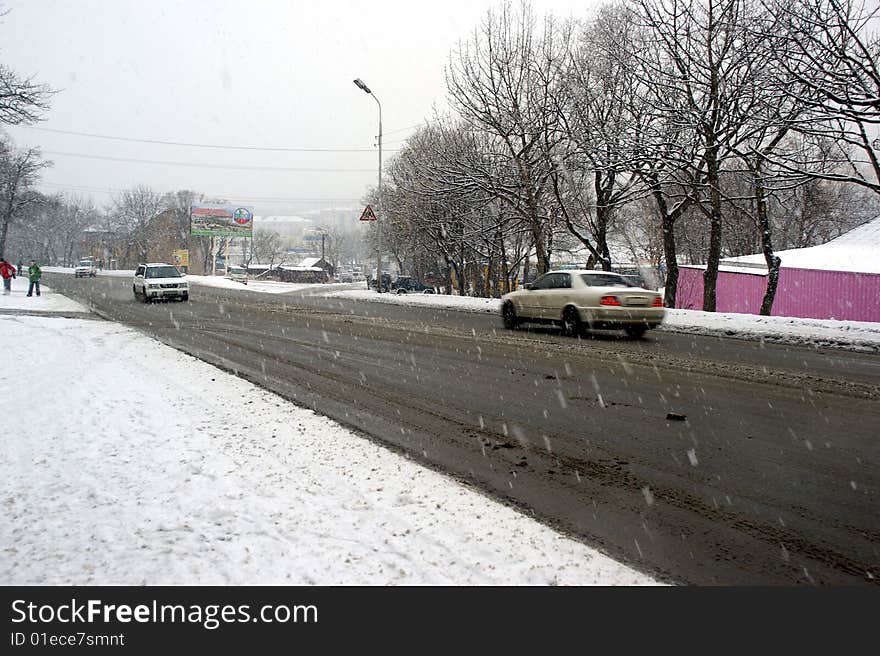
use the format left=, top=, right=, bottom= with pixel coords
left=45, top=274, right=880, bottom=585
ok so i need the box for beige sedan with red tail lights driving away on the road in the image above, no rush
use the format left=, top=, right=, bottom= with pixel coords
left=501, top=269, right=666, bottom=339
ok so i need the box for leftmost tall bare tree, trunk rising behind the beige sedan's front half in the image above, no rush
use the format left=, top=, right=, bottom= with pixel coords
left=446, top=2, right=562, bottom=273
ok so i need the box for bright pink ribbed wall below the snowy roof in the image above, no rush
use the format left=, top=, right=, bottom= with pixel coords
left=675, top=267, right=880, bottom=322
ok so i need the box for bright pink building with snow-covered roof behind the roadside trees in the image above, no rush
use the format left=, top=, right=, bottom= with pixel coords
left=675, top=217, right=880, bottom=322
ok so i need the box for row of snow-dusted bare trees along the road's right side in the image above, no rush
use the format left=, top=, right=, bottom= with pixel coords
left=372, top=0, right=880, bottom=314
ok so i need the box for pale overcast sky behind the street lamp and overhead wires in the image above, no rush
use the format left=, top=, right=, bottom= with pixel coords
left=0, top=0, right=597, bottom=214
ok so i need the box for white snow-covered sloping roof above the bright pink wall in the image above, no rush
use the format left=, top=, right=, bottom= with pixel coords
left=722, top=217, right=880, bottom=273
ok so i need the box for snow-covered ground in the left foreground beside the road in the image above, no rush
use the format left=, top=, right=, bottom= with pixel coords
left=0, top=290, right=657, bottom=585
